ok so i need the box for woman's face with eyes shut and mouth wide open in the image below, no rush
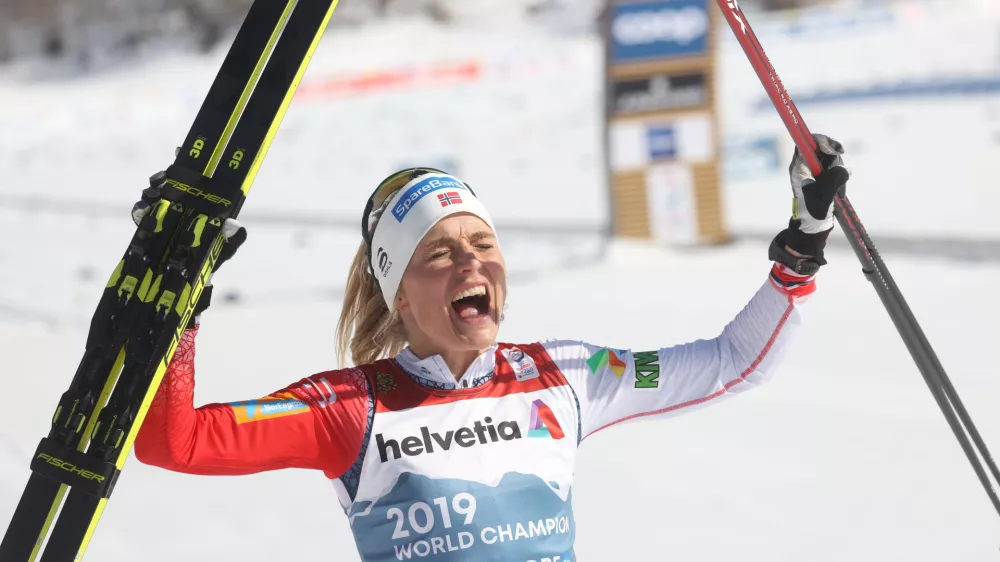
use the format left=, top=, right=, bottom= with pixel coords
left=396, top=213, right=507, bottom=354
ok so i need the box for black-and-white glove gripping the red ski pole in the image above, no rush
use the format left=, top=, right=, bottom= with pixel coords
left=769, top=134, right=851, bottom=273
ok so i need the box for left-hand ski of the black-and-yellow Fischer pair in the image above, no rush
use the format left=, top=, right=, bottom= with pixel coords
left=0, top=1, right=291, bottom=561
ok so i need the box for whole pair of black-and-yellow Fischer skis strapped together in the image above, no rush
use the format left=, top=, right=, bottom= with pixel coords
left=0, top=0, right=336, bottom=562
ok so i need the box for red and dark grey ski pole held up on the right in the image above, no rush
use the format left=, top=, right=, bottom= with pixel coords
left=716, top=0, right=1000, bottom=514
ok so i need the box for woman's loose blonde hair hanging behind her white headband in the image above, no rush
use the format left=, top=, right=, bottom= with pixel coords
left=337, top=242, right=407, bottom=366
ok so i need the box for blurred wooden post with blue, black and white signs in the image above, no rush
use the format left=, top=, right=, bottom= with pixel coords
left=602, top=0, right=729, bottom=246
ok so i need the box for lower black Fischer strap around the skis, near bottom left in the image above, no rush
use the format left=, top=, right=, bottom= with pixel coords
left=31, top=437, right=121, bottom=498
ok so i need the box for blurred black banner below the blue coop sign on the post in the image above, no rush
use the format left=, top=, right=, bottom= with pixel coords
left=611, top=73, right=709, bottom=116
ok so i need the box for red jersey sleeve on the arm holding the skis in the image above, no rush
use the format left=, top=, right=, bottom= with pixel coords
left=135, top=329, right=370, bottom=478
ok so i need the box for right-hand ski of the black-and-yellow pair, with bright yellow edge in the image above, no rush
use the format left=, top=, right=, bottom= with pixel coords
left=42, top=0, right=336, bottom=562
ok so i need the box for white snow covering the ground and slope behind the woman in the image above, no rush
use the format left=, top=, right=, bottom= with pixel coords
left=0, top=2, right=1000, bottom=562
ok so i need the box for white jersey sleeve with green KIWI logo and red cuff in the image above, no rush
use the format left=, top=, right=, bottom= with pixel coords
left=543, top=265, right=815, bottom=439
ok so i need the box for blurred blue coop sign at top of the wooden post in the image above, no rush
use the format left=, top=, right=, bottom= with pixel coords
left=611, top=0, right=709, bottom=63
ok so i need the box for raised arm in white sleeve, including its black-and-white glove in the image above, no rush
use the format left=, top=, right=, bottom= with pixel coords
left=545, top=135, right=850, bottom=438
